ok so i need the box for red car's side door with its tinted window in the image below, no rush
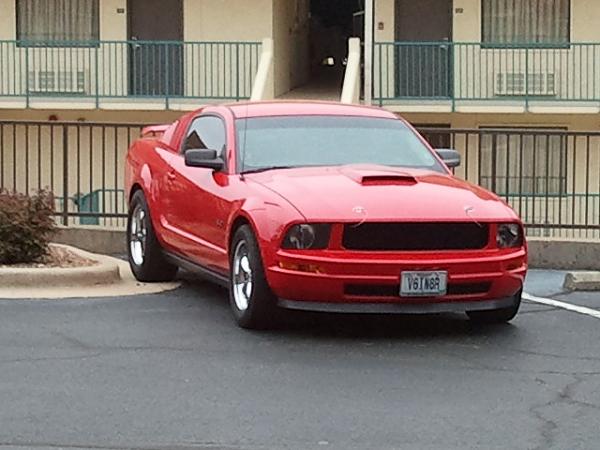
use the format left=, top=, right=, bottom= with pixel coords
left=168, top=115, right=230, bottom=272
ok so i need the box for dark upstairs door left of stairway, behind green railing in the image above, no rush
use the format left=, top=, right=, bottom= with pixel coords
left=128, top=0, right=183, bottom=97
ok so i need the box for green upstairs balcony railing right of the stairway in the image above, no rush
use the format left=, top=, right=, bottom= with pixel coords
left=374, top=42, right=600, bottom=107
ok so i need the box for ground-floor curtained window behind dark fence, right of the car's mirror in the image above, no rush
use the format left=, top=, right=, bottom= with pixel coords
left=480, top=128, right=572, bottom=197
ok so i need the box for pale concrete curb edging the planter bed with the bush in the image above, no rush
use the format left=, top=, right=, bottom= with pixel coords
left=0, top=244, right=121, bottom=288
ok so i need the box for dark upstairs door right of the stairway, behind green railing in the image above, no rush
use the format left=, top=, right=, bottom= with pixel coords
left=395, top=0, right=453, bottom=98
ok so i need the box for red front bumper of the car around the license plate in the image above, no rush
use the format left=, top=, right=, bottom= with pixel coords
left=266, top=248, right=527, bottom=306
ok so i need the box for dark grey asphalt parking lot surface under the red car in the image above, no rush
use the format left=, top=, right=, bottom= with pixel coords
left=0, top=272, right=600, bottom=450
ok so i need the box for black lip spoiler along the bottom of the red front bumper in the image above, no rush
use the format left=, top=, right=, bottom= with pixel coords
left=278, top=297, right=516, bottom=314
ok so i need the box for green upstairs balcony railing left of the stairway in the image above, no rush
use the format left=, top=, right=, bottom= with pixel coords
left=0, top=41, right=261, bottom=108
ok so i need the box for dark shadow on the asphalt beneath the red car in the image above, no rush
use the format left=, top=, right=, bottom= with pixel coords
left=180, top=273, right=518, bottom=340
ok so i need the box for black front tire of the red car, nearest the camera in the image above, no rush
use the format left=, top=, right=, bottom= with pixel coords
left=229, top=225, right=277, bottom=329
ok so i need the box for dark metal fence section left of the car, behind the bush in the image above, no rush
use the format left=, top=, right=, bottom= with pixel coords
left=0, top=121, right=142, bottom=228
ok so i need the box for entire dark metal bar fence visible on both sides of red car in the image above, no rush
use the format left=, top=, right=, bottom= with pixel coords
left=0, top=121, right=600, bottom=239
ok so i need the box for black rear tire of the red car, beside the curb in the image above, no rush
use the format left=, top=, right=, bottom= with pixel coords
left=127, top=190, right=177, bottom=282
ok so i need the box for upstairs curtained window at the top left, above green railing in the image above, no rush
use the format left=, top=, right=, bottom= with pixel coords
left=17, top=0, right=99, bottom=45
